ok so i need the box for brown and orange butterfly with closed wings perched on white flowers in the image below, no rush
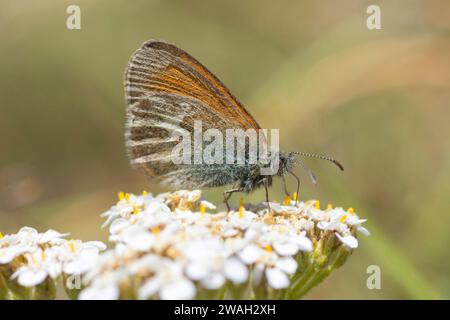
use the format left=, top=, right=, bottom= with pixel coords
left=124, top=40, right=343, bottom=210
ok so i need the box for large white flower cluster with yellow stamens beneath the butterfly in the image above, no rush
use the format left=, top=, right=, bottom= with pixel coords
left=79, top=190, right=368, bottom=299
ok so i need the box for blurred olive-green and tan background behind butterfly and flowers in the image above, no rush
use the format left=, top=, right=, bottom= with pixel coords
left=0, top=0, right=450, bottom=299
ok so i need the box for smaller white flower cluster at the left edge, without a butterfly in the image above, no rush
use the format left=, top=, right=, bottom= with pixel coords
left=0, top=227, right=106, bottom=296
